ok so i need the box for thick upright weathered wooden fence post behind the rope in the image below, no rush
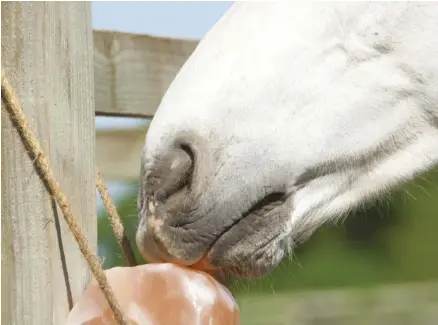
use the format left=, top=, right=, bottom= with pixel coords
left=1, top=1, right=97, bottom=325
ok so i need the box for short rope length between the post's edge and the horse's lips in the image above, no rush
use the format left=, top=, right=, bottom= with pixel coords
left=96, top=170, right=137, bottom=266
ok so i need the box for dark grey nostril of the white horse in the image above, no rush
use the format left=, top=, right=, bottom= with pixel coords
left=148, top=144, right=194, bottom=202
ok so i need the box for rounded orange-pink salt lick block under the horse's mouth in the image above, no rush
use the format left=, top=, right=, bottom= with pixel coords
left=67, top=263, right=239, bottom=325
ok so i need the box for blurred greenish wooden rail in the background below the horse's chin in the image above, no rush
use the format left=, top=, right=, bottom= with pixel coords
left=237, top=281, right=438, bottom=325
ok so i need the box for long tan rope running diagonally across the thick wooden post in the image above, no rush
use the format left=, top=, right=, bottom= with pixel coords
left=2, top=71, right=128, bottom=325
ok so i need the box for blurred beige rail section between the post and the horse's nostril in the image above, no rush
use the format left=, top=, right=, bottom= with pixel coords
left=96, top=127, right=147, bottom=181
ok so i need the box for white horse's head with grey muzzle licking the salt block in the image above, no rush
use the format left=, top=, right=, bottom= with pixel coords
left=137, top=1, right=438, bottom=277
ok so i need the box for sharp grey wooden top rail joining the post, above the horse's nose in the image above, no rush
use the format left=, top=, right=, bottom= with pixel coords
left=94, top=31, right=197, bottom=117
